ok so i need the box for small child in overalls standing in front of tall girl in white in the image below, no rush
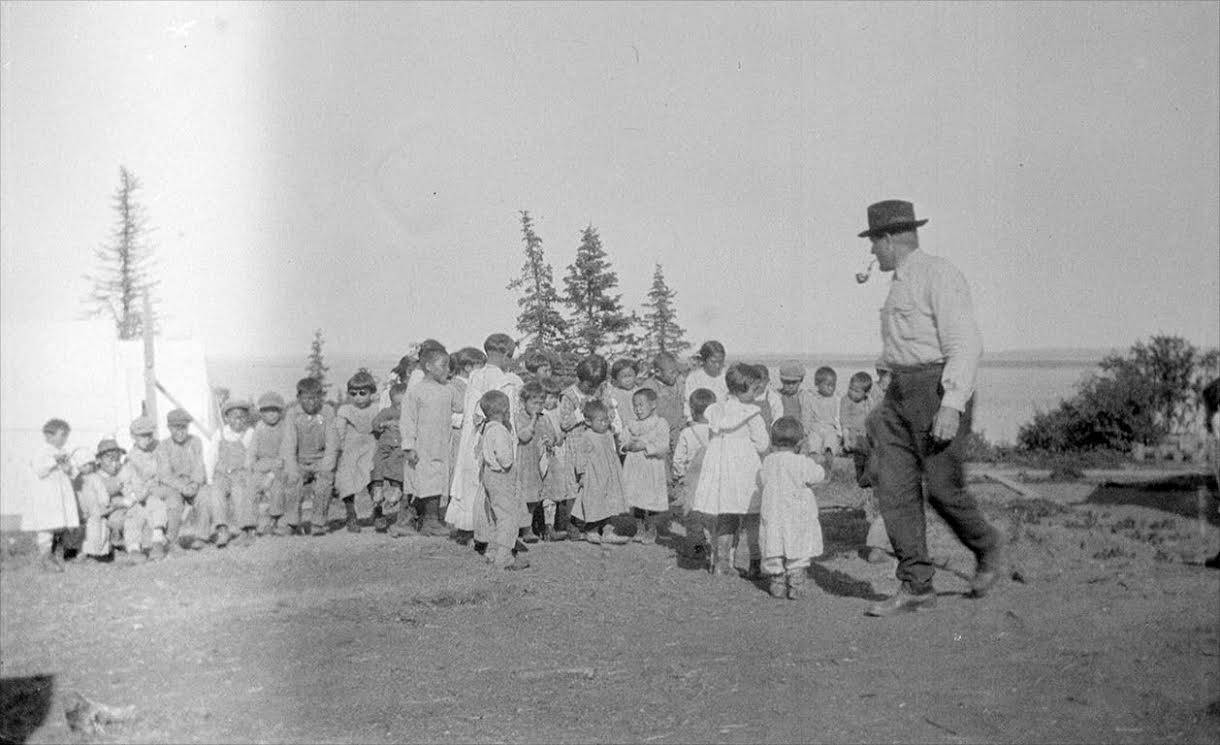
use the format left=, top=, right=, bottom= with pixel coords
left=475, top=390, right=529, bottom=571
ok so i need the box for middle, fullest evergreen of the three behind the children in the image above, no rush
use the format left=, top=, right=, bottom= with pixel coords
left=564, top=224, right=631, bottom=355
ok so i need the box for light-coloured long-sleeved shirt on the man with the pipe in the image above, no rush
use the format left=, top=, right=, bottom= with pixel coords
left=881, top=250, right=983, bottom=411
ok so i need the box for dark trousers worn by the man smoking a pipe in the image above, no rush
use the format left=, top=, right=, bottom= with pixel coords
left=874, top=365, right=998, bottom=594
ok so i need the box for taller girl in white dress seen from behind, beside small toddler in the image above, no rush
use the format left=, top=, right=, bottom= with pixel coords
left=691, top=362, right=771, bottom=574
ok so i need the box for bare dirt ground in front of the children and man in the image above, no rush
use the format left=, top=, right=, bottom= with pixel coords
left=0, top=468, right=1220, bottom=743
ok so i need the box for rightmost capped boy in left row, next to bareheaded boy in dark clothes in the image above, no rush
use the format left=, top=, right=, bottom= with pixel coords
left=245, top=391, right=294, bottom=535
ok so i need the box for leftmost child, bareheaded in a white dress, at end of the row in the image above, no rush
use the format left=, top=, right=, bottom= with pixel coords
left=21, top=419, right=81, bottom=572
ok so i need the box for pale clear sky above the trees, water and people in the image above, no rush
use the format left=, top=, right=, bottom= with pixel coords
left=0, top=2, right=1220, bottom=355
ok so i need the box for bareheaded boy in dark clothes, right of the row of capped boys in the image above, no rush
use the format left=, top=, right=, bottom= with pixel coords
left=279, top=378, right=337, bottom=535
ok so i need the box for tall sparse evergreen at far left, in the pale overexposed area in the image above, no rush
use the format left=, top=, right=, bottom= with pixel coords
left=85, top=166, right=157, bottom=339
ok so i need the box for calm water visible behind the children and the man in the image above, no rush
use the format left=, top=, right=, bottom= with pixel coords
left=207, top=357, right=1096, bottom=443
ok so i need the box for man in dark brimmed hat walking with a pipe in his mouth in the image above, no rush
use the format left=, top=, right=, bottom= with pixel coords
left=860, top=200, right=1003, bottom=616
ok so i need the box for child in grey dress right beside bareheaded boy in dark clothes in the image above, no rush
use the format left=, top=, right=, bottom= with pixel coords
left=314, top=369, right=378, bottom=535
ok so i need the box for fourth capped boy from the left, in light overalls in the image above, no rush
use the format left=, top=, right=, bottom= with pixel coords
left=205, top=399, right=259, bottom=549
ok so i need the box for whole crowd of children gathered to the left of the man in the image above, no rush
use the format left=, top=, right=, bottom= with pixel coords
left=23, top=334, right=885, bottom=597
